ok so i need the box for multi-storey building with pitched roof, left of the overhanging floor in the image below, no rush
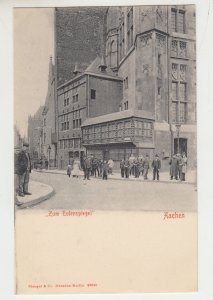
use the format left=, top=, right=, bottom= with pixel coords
left=57, top=56, right=123, bottom=168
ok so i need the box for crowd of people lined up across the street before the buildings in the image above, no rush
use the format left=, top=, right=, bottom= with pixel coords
left=67, top=153, right=187, bottom=181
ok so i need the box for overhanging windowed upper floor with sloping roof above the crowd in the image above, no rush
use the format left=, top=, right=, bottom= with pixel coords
left=81, top=110, right=154, bottom=147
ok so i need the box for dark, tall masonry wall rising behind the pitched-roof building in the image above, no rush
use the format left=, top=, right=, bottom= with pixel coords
left=55, top=7, right=106, bottom=86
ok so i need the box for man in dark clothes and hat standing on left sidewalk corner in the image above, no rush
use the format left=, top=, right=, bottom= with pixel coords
left=16, top=142, right=31, bottom=197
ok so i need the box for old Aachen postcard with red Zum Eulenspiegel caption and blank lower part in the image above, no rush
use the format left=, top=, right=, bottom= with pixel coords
left=13, top=3, right=198, bottom=295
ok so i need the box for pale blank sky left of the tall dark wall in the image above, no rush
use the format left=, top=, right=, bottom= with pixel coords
left=13, top=8, right=54, bottom=136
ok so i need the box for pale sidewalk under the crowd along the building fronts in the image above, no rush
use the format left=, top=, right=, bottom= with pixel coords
left=34, top=169, right=196, bottom=184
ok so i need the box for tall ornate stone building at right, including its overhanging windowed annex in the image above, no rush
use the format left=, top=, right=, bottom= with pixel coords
left=82, top=5, right=196, bottom=168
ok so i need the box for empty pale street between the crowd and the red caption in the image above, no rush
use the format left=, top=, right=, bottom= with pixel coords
left=31, top=172, right=197, bottom=212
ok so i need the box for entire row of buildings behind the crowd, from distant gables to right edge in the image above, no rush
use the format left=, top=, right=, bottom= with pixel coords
left=28, top=5, right=196, bottom=168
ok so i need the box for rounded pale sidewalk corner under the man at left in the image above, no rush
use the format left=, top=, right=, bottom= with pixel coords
left=16, top=180, right=54, bottom=208
